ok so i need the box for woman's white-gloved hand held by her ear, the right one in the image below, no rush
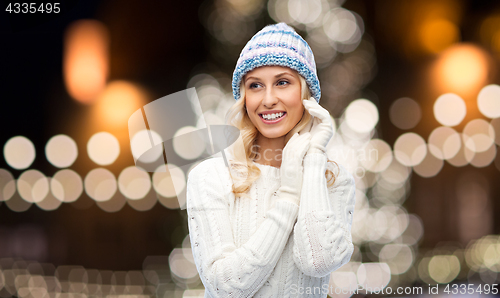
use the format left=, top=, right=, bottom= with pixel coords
left=302, top=97, right=333, bottom=154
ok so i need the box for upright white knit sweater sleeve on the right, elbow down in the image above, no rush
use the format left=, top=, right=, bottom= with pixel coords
left=293, top=153, right=356, bottom=277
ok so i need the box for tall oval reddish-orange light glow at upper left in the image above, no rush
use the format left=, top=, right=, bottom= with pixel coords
left=63, top=20, right=109, bottom=104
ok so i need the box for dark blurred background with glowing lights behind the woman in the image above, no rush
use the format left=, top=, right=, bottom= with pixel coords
left=0, top=0, right=500, bottom=297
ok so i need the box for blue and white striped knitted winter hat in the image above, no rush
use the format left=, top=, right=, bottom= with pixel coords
left=232, top=23, right=321, bottom=103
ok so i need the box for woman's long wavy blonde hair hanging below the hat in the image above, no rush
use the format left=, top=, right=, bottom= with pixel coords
left=225, top=71, right=340, bottom=198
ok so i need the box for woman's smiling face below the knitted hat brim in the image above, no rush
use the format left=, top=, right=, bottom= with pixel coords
left=243, top=66, right=304, bottom=138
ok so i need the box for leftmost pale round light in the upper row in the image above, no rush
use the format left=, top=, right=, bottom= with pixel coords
left=3, top=136, right=36, bottom=170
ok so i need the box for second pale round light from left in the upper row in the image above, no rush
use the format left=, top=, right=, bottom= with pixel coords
left=45, top=135, right=78, bottom=168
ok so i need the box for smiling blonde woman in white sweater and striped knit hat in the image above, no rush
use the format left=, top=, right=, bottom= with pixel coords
left=187, top=23, right=355, bottom=297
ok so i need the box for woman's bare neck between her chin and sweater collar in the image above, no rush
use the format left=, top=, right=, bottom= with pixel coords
left=255, top=133, right=286, bottom=168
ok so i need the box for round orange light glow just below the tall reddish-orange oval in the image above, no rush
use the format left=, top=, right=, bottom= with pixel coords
left=96, top=81, right=147, bottom=127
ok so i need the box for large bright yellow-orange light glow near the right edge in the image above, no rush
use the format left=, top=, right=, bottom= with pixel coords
left=433, top=43, right=489, bottom=96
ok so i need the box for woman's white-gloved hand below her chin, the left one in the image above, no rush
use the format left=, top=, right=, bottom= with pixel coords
left=279, top=132, right=311, bottom=204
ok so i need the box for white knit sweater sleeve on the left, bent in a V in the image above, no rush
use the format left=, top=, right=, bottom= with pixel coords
left=186, top=159, right=299, bottom=297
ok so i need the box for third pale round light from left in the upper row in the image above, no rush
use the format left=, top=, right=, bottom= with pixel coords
left=87, top=131, right=120, bottom=166
